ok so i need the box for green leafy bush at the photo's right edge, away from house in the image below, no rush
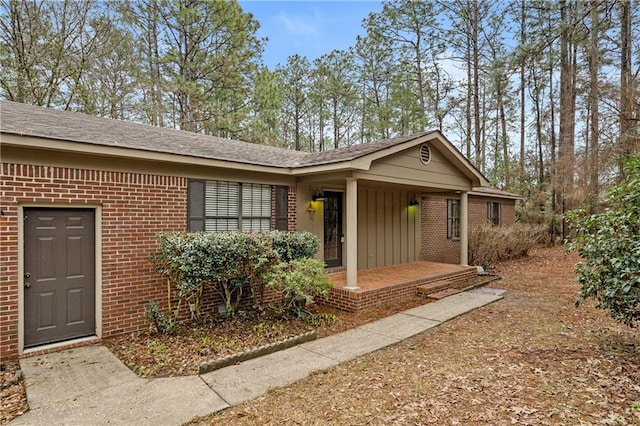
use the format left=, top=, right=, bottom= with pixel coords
left=566, top=157, right=640, bottom=327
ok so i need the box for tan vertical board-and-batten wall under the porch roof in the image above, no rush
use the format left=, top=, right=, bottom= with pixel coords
left=358, top=188, right=420, bottom=269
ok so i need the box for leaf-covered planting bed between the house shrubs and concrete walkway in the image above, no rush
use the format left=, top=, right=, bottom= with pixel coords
left=103, top=296, right=427, bottom=377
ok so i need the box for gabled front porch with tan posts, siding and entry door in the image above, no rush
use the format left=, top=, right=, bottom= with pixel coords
left=296, top=132, right=486, bottom=292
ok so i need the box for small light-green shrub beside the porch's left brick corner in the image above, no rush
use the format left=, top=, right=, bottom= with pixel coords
left=264, top=258, right=332, bottom=316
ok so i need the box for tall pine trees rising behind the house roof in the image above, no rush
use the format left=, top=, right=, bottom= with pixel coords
left=0, top=0, right=640, bottom=236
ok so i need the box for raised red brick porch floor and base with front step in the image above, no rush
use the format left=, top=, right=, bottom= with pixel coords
left=322, top=261, right=495, bottom=312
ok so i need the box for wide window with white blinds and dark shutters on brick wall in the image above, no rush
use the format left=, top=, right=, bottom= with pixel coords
left=188, top=180, right=287, bottom=231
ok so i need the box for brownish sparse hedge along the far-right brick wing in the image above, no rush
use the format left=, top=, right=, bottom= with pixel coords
left=469, top=223, right=548, bottom=265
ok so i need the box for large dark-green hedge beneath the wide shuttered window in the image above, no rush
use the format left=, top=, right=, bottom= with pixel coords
left=151, top=231, right=323, bottom=321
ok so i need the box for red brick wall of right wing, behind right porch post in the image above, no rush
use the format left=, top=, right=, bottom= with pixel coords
left=420, top=195, right=516, bottom=264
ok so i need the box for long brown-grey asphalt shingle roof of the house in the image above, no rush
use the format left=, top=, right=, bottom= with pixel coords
left=0, top=101, right=425, bottom=168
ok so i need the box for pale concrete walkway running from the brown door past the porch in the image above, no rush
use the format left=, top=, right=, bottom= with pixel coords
left=10, top=288, right=502, bottom=426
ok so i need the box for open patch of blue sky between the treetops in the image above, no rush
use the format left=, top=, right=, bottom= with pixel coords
left=238, top=0, right=382, bottom=70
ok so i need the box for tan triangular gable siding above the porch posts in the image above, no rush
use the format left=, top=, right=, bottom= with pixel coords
left=356, top=143, right=471, bottom=190
